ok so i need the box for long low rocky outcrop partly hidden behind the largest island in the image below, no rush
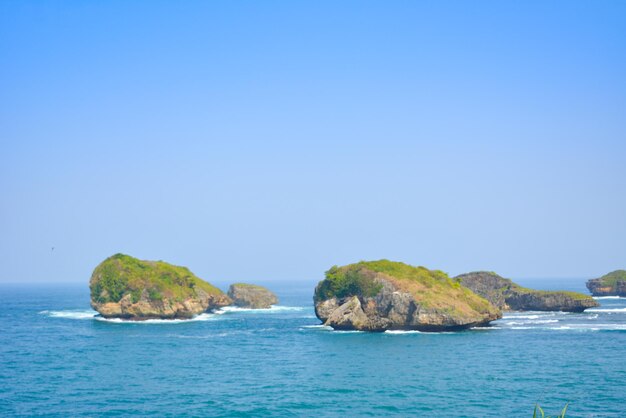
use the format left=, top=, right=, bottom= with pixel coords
left=455, top=271, right=599, bottom=312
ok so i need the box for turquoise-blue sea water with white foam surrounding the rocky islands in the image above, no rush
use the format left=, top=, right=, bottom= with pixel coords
left=0, top=280, right=626, bottom=417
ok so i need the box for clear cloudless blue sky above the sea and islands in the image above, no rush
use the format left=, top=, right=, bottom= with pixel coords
left=0, top=0, right=626, bottom=282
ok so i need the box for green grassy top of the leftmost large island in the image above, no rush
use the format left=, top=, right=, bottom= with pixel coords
left=90, top=254, right=223, bottom=303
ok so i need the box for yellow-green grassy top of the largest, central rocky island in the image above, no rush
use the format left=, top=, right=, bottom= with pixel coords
left=315, top=260, right=494, bottom=311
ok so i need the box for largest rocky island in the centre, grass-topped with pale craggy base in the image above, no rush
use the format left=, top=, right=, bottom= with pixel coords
left=314, top=260, right=502, bottom=331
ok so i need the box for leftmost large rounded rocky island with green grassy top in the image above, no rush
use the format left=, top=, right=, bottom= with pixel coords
left=89, top=254, right=232, bottom=320
